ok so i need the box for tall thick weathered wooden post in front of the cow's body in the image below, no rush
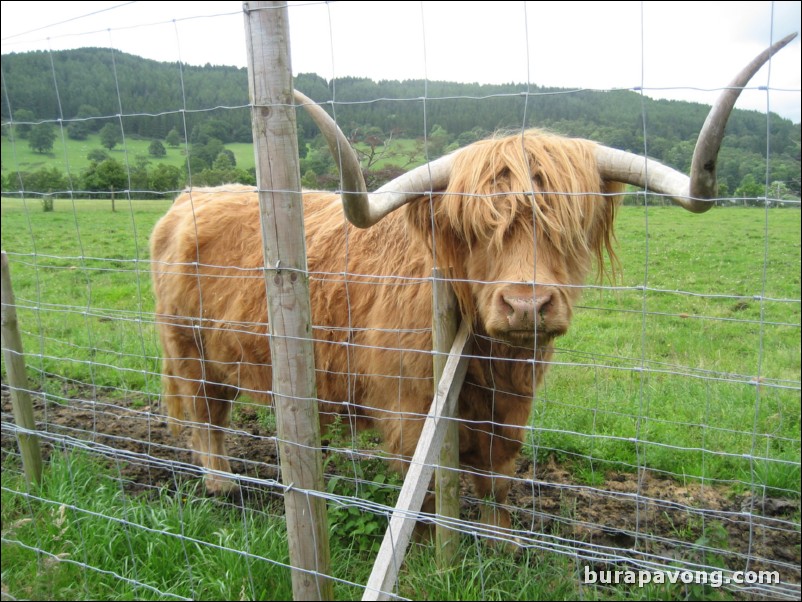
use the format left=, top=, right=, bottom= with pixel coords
left=243, top=2, right=334, bottom=600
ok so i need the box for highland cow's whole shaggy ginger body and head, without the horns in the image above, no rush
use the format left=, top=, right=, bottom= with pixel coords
left=151, top=132, right=620, bottom=527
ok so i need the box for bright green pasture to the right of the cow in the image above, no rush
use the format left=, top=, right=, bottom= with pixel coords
left=533, top=208, right=800, bottom=496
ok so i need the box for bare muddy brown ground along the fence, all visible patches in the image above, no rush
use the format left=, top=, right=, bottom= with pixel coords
left=2, top=384, right=800, bottom=597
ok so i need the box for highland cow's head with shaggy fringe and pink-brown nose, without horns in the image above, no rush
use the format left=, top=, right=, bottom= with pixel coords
left=408, top=136, right=616, bottom=346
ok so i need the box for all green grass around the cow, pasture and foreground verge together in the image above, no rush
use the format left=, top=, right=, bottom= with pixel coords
left=2, top=197, right=801, bottom=600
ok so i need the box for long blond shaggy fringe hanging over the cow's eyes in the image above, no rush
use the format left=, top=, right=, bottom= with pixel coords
left=435, top=130, right=623, bottom=277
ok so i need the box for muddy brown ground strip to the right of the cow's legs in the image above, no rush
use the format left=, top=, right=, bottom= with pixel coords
left=513, top=461, right=800, bottom=584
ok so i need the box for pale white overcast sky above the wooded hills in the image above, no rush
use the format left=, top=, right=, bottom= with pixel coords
left=0, top=1, right=802, bottom=122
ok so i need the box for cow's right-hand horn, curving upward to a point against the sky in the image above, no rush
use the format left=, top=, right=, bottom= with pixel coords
left=596, top=33, right=797, bottom=213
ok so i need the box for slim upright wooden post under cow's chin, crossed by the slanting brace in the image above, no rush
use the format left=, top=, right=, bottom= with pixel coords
left=432, top=268, right=459, bottom=568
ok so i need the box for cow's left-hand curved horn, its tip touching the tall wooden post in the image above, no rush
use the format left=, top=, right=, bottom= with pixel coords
left=295, top=90, right=454, bottom=228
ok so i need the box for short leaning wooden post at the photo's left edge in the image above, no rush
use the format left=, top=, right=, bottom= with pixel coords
left=0, top=251, right=42, bottom=485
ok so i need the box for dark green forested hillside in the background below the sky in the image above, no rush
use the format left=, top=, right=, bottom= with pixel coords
left=2, top=48, right=800, bottom=197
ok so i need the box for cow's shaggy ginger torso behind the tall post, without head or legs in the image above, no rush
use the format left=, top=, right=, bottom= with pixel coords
left=151, top=186, right=432, bottom=432
